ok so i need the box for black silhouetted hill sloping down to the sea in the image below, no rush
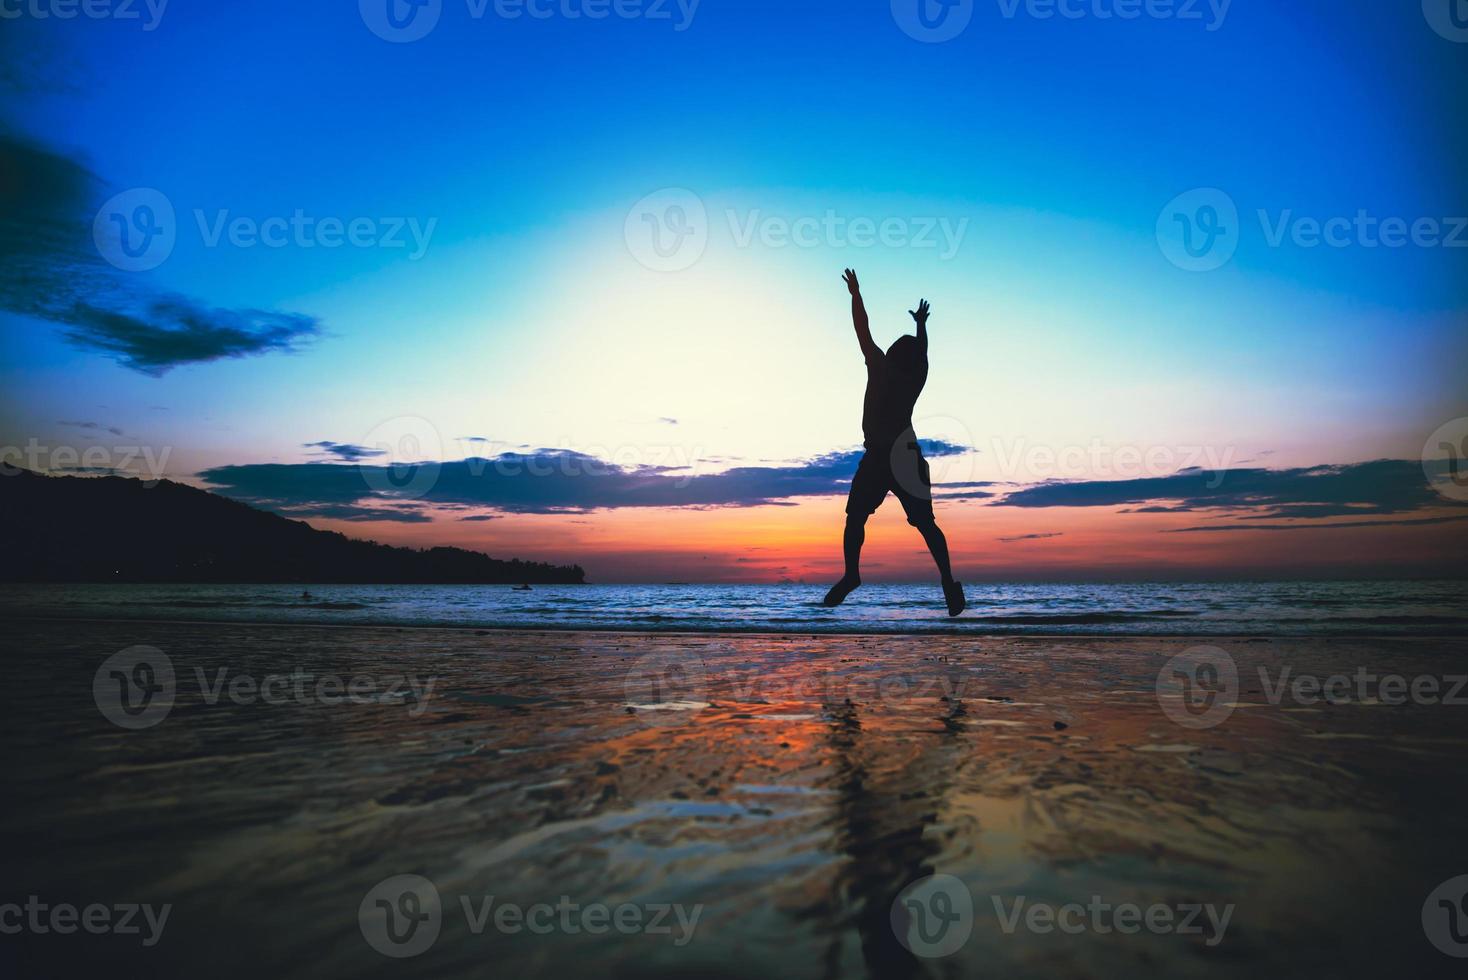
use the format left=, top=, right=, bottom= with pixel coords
left=0, top=467, right=586, bottom=585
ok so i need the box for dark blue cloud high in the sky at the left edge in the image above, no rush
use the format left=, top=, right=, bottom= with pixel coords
left=0, top=134, right=320, bottom=377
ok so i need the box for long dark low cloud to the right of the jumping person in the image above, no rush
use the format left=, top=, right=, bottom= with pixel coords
left=997, top=459, right=1449, bottom=530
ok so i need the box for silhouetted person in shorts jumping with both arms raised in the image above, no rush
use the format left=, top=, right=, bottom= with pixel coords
left=825, top=268, right=967, bottom=616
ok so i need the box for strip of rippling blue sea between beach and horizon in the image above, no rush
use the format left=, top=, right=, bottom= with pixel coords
left=0, top=581, right=1468, bottom=637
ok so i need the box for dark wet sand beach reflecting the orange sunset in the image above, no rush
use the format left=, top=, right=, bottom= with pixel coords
left=0, top=619, right=1468, bottom=977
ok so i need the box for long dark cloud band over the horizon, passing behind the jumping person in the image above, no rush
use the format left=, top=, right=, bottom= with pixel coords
left=200, top=442, right=986, bottom=513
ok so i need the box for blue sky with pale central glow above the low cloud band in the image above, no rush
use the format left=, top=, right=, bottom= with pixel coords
left=0, top=0, right=1468, bottom=578
